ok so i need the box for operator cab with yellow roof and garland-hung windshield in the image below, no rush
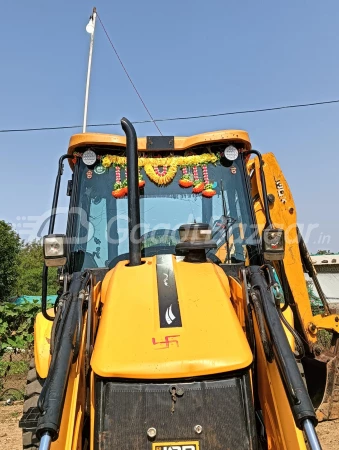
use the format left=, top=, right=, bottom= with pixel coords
left=67, top=131, right=258, bottom=271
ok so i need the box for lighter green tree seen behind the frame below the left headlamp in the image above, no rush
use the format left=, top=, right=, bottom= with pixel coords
left=16, top=240, right=59, bottom=296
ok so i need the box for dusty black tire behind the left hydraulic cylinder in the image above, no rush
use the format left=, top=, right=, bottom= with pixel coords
left=22, top=359, right=44, bottom=450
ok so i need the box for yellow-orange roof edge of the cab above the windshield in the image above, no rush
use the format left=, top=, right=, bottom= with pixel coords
left=68, top=130, right=251, bottom=154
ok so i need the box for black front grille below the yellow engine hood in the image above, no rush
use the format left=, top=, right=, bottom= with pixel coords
left=95, top=376, right=256, bottom=450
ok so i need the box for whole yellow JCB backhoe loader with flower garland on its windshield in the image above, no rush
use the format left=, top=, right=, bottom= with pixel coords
left=20, top=118, right=339, bottom=450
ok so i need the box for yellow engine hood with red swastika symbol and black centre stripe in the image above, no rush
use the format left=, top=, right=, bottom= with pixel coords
left=91, top=256, right=252, bottom=379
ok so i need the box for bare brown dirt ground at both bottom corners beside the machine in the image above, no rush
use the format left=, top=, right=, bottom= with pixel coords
left=0, top=402, right=339, bottom=450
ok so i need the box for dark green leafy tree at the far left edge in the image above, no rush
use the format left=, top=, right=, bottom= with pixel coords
left=0, top=220, right=21, bottom=301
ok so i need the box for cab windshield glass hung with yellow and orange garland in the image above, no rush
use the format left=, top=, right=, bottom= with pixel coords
left=72, top=147, right=257, bottom=270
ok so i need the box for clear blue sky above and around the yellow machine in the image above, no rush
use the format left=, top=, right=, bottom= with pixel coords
left=0, top=0, right=339, bottom=252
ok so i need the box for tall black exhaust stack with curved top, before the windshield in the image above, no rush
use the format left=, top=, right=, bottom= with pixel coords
left=121, top=117, right=141, bottom=266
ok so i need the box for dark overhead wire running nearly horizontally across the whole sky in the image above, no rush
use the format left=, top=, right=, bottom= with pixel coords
left=0, top=100, right=339, bottom=133
